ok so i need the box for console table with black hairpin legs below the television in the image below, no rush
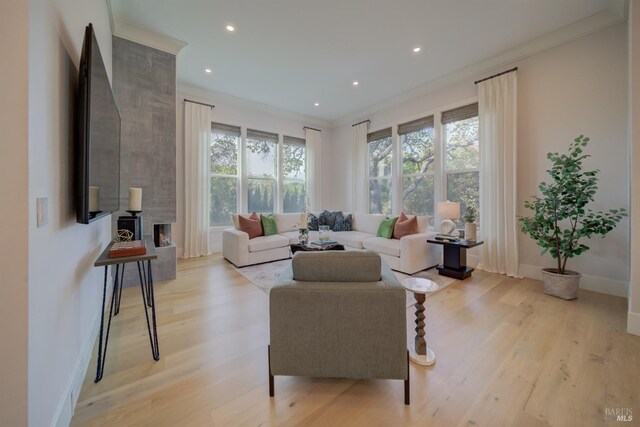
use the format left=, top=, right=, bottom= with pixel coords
left=93, top=236, right=160, bottom=383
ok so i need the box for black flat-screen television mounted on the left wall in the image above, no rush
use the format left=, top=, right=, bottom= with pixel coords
left=75, top=24, right=120, bottom=224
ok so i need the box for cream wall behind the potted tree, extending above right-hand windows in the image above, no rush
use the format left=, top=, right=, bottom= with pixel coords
left=324, top=24, right=629, bottom=296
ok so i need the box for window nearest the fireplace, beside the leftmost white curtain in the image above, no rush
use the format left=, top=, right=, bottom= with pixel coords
left=209, top=123, right=240, bottom=226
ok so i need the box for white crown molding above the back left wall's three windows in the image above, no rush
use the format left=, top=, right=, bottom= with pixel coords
left=177, top=80, right=332, bottom=130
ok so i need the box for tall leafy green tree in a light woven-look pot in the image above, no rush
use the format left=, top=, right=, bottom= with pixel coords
left=518, top=135, right=627, bottom=299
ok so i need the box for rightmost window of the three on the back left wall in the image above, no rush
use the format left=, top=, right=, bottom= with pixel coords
left=282, top=136, right=306, bottom=213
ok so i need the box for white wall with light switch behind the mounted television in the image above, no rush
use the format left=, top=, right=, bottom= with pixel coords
left=29, top=0, right=111, bottom=426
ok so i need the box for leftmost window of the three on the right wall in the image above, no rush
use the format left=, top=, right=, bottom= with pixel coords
left=367, top=128, right=393, bottom=214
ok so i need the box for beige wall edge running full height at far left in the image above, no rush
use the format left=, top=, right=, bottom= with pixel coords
left=0, top=0, right=29, bottom=426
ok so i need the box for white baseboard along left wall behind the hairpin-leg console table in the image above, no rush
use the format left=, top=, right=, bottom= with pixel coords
left=51, top=276, right=113, bottom=427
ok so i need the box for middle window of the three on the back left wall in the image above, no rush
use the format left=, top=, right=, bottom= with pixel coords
left=247, top=129, right=278, bottom=212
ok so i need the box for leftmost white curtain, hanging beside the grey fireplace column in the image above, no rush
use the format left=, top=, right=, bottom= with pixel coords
left=183, top=102, right=211, bottom=258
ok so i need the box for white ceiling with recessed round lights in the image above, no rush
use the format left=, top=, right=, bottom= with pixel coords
left=110, top=0, right=612, bottom=121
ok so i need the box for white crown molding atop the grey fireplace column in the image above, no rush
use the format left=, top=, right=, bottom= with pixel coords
left=107, top=0, right=187, bottom=56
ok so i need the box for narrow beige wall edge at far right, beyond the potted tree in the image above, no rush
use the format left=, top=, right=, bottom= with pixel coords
left=627, top=1, right=640, bottom=335
